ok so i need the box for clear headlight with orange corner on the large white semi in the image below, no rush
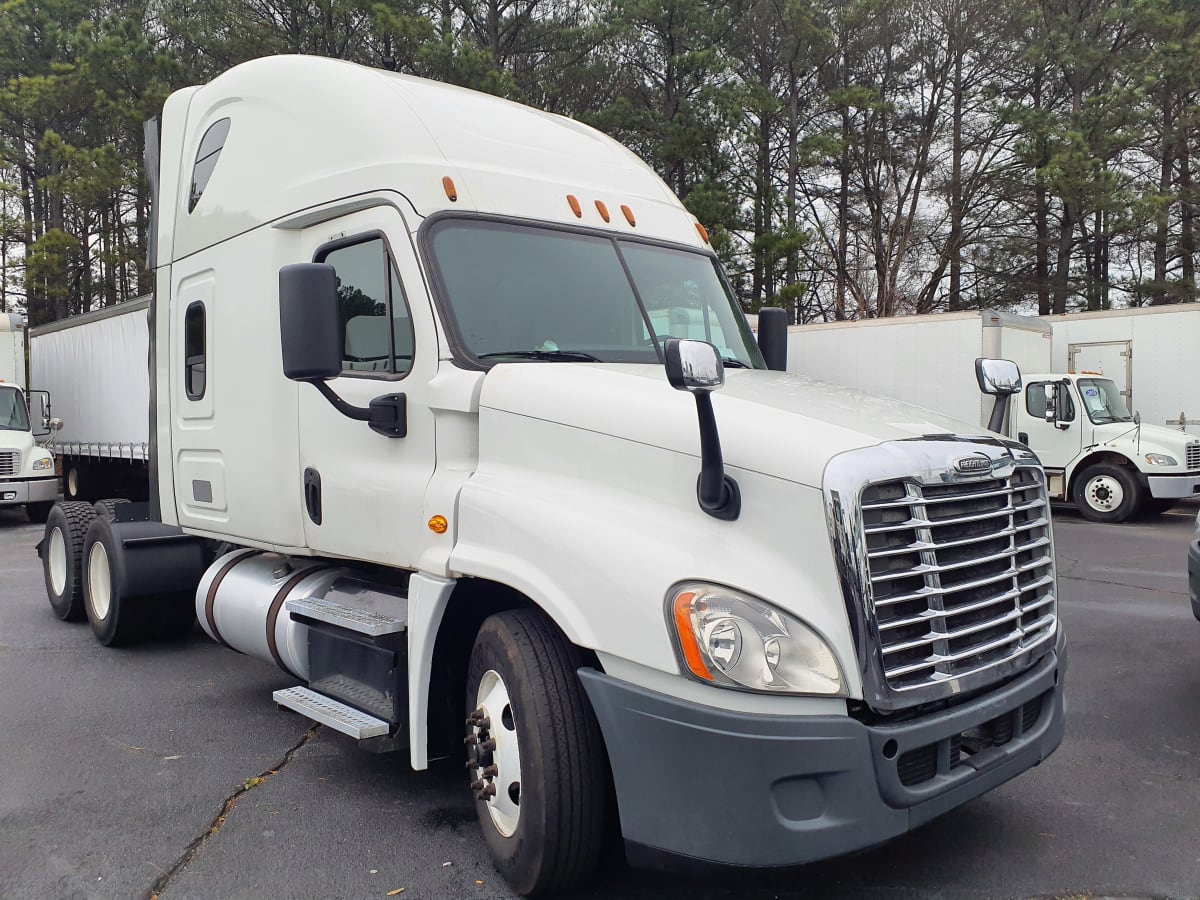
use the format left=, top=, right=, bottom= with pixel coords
left=667, top=582, right=844, bottom=696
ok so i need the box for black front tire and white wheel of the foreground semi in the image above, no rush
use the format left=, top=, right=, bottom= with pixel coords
left=466, top=610, right=606, bottom=895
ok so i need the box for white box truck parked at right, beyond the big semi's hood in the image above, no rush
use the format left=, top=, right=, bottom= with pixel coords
left=788, top=310, right=1200, bottom=522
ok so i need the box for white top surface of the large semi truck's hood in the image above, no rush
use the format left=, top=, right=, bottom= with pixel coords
left=479, top=362, right=997, bottom=487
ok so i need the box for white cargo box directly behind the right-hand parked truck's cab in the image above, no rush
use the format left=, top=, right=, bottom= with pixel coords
left=787, top=310, right=1051, bottom=424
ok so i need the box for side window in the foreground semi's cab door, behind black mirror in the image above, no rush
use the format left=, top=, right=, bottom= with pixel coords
left=318, top=238, right=413, bottom=374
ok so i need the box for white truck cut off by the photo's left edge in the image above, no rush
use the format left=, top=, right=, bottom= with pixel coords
left=0, top=313, right=59, bottom=522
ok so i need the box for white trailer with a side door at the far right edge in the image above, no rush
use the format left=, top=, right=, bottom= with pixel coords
left=1046, top=304, right=1200, bottom=437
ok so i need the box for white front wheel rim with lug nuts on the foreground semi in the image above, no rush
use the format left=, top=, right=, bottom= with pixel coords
left=466, top=668, right=521, bottom=838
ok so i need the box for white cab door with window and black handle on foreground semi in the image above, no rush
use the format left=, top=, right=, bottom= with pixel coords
left=295, top=206, right=438, bottom=568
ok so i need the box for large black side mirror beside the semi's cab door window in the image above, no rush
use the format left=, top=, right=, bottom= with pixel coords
left=280, top=263, right=342, bottom=382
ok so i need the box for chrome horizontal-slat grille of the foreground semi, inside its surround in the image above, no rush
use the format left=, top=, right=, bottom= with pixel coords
left=860, top=467, right=1057, bottom=691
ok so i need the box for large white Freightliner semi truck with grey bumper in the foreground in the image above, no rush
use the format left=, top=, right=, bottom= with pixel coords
left=41, top=56, right=1066, bottom=894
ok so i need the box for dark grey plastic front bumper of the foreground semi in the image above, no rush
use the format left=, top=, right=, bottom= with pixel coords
left=580, top=632, right=1066, bottom=866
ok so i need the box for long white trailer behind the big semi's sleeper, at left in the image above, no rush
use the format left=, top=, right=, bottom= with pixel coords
left=29, top=296, right=150, bottom=500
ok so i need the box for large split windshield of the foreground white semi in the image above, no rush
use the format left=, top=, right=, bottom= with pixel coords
left=428, top=218, right=763, bottom=368
